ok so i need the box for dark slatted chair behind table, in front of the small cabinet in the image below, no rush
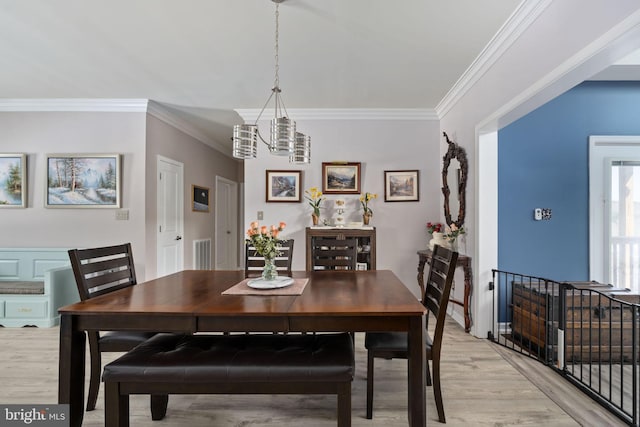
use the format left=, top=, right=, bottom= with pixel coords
left=311, top=238, right=358, bottom=270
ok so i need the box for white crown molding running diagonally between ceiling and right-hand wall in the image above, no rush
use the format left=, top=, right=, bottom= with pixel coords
left=435, top=0, right=553, bottom=117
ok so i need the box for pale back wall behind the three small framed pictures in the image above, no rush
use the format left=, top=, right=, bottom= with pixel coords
left=243, top=114, right=442, bottom=295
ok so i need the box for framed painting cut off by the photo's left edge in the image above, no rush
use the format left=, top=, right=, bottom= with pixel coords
left=0, top=153, right=28, bottom=208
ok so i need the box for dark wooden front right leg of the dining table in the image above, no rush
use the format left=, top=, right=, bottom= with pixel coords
left=408, top=316, right=427, bottom=427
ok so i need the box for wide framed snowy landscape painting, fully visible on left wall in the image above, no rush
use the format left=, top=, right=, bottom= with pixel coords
left=44, top=153, right=122, bottom=209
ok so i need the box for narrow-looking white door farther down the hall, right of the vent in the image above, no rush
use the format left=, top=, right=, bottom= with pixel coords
left=216, top=176, right=239, bottom=270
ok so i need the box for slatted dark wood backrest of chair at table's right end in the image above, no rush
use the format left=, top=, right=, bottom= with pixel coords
left=422, top=245, right=458, bottom=346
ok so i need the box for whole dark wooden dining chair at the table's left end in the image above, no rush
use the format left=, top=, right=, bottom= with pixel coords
left=69, top=243, right=167, bottom=419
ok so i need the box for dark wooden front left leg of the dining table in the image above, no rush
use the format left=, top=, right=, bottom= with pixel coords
left=58, top=314, right=86, bottom=427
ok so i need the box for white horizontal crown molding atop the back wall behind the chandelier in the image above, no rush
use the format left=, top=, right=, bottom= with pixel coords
left=235, top=108, right=439, bottom=123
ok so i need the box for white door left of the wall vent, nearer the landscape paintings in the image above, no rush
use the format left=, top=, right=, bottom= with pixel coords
left=156, top=156, right=184, bottom=277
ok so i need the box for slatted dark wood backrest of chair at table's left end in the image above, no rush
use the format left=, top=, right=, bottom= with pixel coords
left=69, top=243, right=137, bottom=301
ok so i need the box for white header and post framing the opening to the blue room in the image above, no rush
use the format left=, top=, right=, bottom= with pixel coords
left=441, top=0, right=640, bottom=337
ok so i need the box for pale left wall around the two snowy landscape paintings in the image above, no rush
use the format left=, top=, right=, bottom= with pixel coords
left=0, top=112, right=145, bottom=277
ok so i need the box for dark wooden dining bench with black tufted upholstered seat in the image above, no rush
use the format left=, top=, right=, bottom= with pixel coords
left=102, top=333, right=355, bottom=427
